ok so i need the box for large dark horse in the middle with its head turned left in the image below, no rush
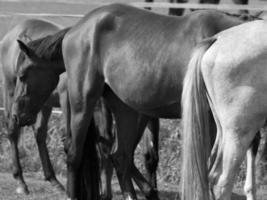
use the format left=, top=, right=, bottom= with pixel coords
left=12, top=4, right=262, bottom=200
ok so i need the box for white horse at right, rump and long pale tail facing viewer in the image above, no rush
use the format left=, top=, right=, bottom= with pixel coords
left=182, top=20, right=267, bottom=200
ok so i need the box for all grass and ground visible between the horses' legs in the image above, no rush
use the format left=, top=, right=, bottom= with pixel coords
left=0, top=115, right=267, bottom=200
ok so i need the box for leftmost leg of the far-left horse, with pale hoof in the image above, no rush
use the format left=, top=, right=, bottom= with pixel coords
left=3, top=85, right=29, bottom=194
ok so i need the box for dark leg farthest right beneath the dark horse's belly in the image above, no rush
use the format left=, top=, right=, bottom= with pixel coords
left=144, top=118, right=159, bottom=189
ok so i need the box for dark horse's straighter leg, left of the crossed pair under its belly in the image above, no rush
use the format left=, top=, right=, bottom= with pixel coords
left=111, top=109, right=138, bottom=200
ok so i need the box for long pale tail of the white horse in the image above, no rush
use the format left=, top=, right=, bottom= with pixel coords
left=182, top=38, right=216, bottom=200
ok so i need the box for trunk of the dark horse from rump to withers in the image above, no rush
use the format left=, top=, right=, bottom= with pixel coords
left=63, top=4, right=250, bottom=117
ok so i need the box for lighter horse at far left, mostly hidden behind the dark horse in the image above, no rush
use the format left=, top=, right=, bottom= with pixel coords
left=0, top=19, right=159, bottom=199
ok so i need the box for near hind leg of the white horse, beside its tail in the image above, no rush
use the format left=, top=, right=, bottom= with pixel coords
left=209, top=118, right=261, bottom=200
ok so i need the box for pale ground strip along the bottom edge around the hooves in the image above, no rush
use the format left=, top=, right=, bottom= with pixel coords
left=0, top=173, right=267, bottom=200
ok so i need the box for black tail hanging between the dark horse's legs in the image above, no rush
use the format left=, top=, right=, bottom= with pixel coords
left=78, top=118, right=100, bottom=200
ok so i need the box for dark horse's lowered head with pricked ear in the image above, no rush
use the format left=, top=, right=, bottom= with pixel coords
left=12, top=40, right=59, bottom=126
